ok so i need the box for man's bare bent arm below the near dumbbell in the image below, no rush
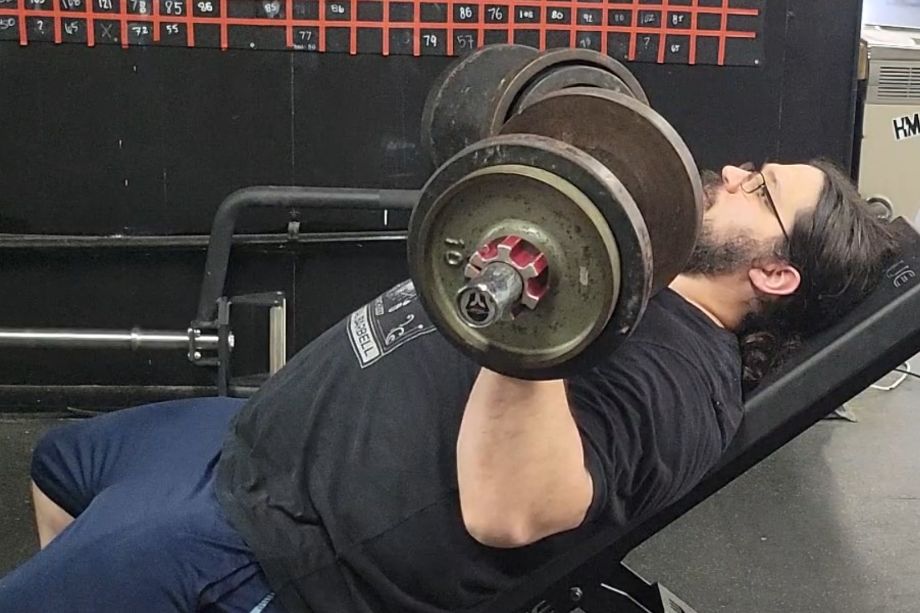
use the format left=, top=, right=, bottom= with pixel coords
left=457, top=369, right=593, bottom=547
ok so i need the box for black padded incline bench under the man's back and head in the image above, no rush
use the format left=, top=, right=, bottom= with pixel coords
left=480, top=219, right=920, bottom=613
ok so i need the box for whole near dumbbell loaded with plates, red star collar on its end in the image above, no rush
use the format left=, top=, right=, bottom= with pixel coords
left=409, top=51, right=703, bottom=379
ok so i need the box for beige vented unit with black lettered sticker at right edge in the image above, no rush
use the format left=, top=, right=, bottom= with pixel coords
left=859, top=26, right=920, bottom=228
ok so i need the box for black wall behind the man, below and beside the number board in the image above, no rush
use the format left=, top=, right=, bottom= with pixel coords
left=0, top=0, right=860, bottom=406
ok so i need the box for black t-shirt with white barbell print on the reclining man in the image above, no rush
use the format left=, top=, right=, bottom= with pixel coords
left=218, top=282, right=742, bottom=613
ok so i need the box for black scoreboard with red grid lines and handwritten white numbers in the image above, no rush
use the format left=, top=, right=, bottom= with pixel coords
left=0, top=0, right=766, bottom=66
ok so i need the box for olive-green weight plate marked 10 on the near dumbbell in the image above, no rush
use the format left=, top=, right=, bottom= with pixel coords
left=425, top=164, right=619, bottom=369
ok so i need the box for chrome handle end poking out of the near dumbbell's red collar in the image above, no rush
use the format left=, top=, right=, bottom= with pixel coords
left=457, top=262, right=524, bottom=328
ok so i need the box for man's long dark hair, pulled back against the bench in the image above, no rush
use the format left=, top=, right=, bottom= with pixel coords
left=738, top=160, right=895, bottom=391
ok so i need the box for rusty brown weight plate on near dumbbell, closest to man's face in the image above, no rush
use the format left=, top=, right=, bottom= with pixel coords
left=502, top=87, right=704, bottom=291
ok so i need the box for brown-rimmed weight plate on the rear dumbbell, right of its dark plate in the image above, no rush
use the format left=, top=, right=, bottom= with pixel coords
left=488, top=49, right=648, bottom=135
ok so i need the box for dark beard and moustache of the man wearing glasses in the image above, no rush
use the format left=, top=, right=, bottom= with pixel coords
left=684, top=170, right=773, bottom=276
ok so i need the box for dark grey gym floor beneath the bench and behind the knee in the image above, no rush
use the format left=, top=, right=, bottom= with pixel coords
left=0, top=357, right=920, bottom=613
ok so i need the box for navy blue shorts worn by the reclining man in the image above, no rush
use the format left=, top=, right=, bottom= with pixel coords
left=0, top=398, right=281, bottom=613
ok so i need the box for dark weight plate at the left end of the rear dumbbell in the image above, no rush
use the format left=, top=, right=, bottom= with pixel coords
left=421, top=45, right=539, bottom=166
